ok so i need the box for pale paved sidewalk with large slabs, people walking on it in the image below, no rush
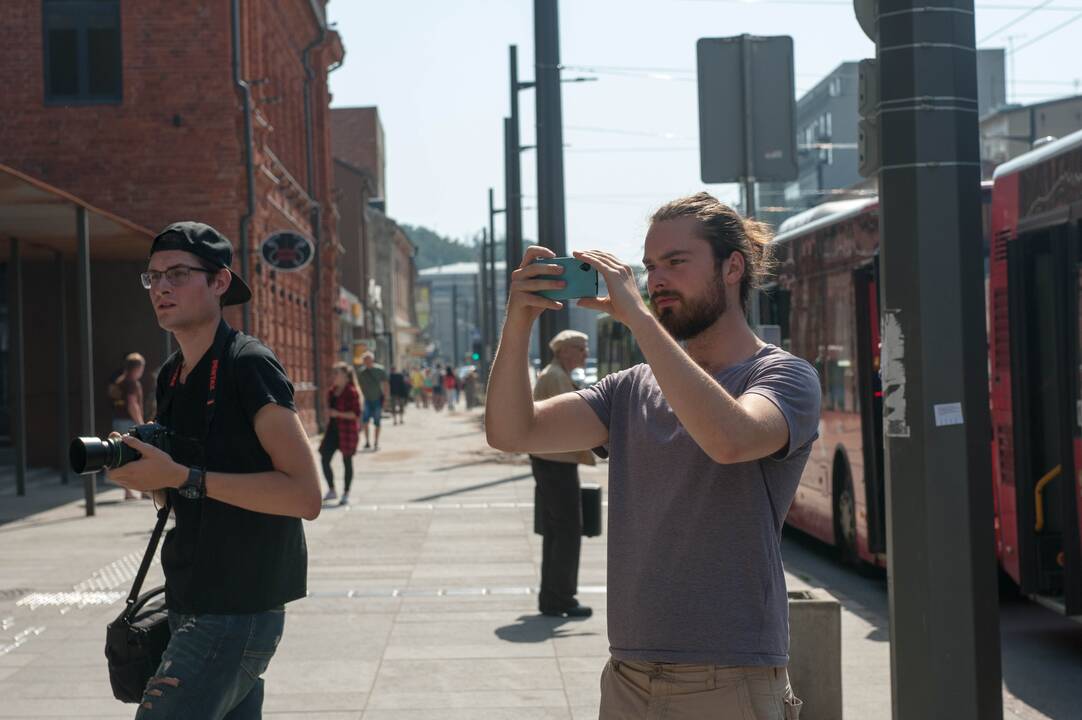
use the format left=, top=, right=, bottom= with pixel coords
left=6, top=400, right=1064, bottom=720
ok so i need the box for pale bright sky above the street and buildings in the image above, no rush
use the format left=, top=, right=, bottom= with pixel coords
left=328, top=0, right=1082, bottom=261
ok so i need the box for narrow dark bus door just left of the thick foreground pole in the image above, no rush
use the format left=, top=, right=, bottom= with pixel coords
left=853, top=257, right=886, bottom=552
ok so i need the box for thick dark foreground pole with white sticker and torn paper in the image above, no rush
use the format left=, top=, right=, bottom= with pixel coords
left=875, top=0, right=1003, bottom=720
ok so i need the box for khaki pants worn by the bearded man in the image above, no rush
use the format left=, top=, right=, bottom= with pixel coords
left=599, top=659, right=802, bottom=720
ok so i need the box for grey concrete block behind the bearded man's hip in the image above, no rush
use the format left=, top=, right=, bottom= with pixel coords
left=789, top=588, right=842, bottom=720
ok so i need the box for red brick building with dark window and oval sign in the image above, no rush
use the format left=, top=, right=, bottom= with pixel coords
left=0, top=0, right=344, bottom=431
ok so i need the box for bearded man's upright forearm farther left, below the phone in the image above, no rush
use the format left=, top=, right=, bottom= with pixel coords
left=485, top=316, right=533, bottom=448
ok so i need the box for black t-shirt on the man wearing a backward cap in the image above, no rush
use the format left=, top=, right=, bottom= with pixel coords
left=157, top=322, right=308, bottom=614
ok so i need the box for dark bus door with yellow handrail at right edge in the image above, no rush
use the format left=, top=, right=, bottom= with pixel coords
left=1008, top=224, right=1082, bottom=615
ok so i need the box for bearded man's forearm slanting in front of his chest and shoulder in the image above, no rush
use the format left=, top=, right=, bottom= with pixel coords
left=632, top=316, right=751, bottom=462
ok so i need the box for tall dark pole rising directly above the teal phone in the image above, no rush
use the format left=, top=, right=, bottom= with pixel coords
left=533, top=0, right=570, bottom=366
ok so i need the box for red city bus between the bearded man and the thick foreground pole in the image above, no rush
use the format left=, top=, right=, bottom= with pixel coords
left=760, top=188, right=991, bottom=566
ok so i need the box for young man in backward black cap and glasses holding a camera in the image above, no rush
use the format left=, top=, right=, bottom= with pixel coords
left=110, top=222, right=321, bottom=720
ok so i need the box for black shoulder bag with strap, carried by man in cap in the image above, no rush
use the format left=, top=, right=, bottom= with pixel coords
left=105, top=322, right=234, bottom=703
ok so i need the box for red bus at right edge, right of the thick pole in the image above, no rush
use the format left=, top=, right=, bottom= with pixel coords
left=988, top=131, right=1082, bottom=615
